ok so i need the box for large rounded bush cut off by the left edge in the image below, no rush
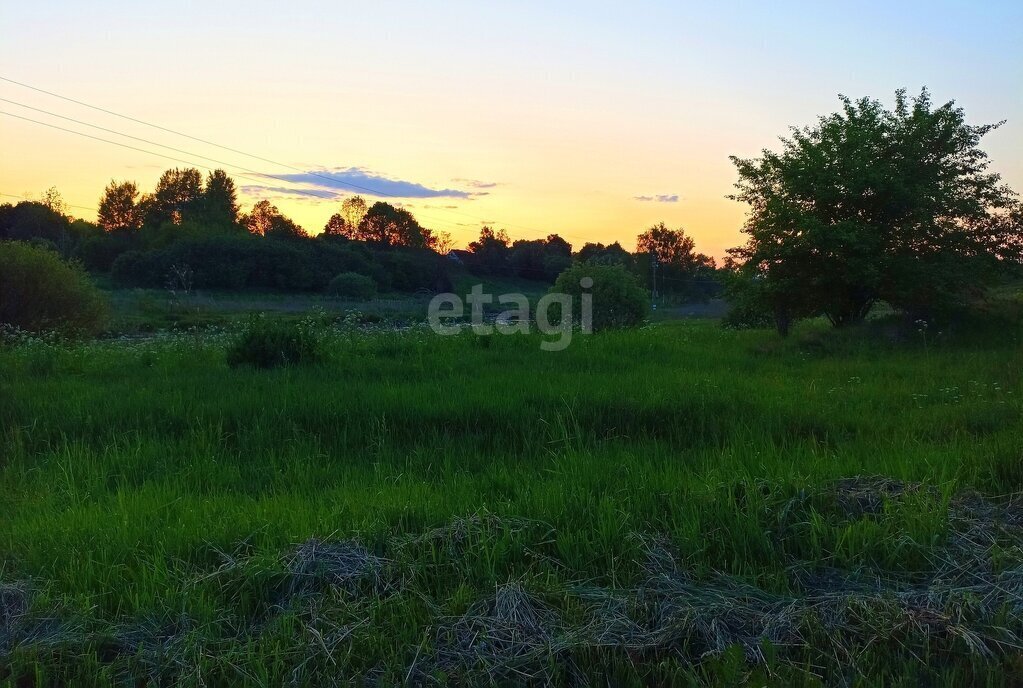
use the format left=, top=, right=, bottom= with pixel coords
left=0, top=241, right=107, bottom=334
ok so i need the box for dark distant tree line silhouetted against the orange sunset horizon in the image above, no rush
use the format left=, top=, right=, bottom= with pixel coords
left=0, top=168, right=720, bottom=301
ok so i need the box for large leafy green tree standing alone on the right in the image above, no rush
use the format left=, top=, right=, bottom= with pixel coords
left=731, top=89, right=1023, bottom=332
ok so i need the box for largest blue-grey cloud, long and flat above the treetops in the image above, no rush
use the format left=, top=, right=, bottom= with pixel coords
left=241, top=168, right=491, bottom=200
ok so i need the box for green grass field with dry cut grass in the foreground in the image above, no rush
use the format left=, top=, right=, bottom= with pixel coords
left=0, top=314, right=1023, bottom=686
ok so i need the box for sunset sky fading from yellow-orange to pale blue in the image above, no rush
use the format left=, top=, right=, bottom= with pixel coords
left=0, top=0, right=1023, bottom=258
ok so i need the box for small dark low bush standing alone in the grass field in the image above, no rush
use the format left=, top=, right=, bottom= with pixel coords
left=227, top=316, right=323, bottom=368
